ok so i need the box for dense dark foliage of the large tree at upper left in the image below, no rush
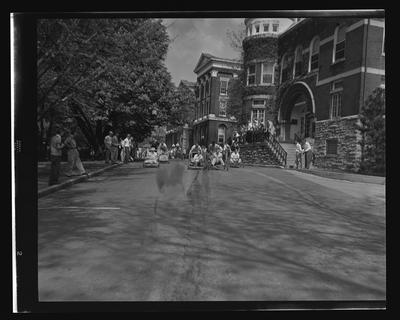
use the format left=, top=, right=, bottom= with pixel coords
left=37, top=19, right=174, bottom=158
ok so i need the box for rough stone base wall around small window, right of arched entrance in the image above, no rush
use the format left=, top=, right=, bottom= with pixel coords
left=313, top=117, right=361, bottom=172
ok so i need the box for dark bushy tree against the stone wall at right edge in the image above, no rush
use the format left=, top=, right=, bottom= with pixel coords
left=358, top=88, right=386, bottom=174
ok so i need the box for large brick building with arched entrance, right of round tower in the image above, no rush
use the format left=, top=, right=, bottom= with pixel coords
left=276, top=18, right=385, bottom=170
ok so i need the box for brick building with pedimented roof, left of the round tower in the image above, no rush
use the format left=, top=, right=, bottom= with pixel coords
left=192, top=53, right=242, bottom=145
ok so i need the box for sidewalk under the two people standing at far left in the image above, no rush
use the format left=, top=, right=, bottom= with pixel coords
left=37, top=161, right=122, bottom=197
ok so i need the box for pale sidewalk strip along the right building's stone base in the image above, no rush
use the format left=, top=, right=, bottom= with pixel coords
left=288, top=167, right=386, bottom=185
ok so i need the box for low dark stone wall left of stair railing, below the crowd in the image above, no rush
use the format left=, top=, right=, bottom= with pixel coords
left=240, top=143, right=280, bottom=165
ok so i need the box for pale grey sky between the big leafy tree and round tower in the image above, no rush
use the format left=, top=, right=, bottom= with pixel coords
left=163, top=18, right=290, bottom=85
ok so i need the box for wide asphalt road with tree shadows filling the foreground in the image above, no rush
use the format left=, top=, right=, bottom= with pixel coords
left=38, top=162, right=386, bottom=301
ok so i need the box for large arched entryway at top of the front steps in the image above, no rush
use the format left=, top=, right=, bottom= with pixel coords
left=279, top=82, right=315, bottom=142
